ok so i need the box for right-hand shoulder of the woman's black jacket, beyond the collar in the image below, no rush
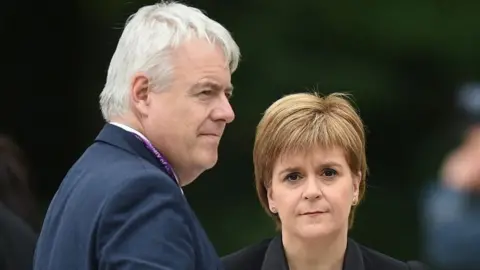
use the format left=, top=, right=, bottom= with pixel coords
left=358, top=245, right=428, bottom=270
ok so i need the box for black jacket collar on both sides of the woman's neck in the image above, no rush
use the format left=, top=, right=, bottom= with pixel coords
left=261, top=236, right=365, bottom=270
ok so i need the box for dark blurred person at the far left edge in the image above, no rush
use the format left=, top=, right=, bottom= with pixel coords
left=0, top=135, right=37, bottom=270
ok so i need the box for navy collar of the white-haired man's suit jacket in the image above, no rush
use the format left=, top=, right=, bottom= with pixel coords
left=95, top=124, right=178, bottom=187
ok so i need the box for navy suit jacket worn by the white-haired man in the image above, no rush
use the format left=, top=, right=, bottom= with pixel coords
left=34, top=124, right=222, bottom=270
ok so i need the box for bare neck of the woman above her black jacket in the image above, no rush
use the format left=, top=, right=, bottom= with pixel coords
left=282, top=231, right=347, bottom=270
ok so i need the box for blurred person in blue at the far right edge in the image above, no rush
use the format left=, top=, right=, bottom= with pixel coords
left=422, top=85, right=480, bottom=270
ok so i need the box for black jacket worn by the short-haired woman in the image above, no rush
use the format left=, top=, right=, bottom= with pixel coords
left=222, top=236, right=426, bottom=270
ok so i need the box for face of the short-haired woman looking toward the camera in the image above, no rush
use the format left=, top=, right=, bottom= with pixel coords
left=268, top=147, right=361, bottom=239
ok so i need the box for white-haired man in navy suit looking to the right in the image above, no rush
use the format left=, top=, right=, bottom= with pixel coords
left=34, top=3, right=240, bottom=270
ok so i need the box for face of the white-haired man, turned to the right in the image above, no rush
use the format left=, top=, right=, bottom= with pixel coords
left=142, top=39, right=235, bottom=185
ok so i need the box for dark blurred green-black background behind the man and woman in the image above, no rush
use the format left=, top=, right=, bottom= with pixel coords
left=0, top=0, right=480, bottom=259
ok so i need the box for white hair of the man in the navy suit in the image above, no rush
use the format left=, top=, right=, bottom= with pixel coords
left=100, top=1, right=240, bottom=121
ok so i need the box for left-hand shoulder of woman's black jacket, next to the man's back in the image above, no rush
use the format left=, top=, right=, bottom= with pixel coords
left=221, top=239, right=271, bottom=270
